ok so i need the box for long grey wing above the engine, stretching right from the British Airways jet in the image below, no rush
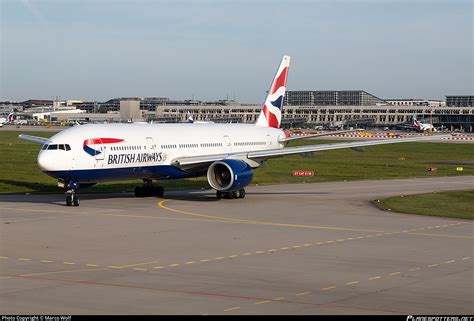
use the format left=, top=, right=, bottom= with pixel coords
left=171, top=135, right=451, bottom=171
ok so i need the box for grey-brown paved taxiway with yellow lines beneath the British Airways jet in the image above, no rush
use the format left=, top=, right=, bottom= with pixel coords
left=0, top=176, right=474, bottom=315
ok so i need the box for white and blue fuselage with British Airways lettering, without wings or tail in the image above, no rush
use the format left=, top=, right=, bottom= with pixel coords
left=38, top=123, right=284, bottom=182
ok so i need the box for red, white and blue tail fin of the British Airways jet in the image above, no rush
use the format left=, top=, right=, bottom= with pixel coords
left=256, top=56, right=290, bottom=128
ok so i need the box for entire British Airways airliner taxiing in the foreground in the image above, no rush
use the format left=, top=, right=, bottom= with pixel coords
left=19, top=56, right=448, bottom=206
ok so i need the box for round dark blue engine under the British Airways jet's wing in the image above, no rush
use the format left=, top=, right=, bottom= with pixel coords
left=207, top=159, right=253, bottom=192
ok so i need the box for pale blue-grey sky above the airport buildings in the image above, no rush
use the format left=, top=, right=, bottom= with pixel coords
left=0, top=0, right=474, bottom=103
